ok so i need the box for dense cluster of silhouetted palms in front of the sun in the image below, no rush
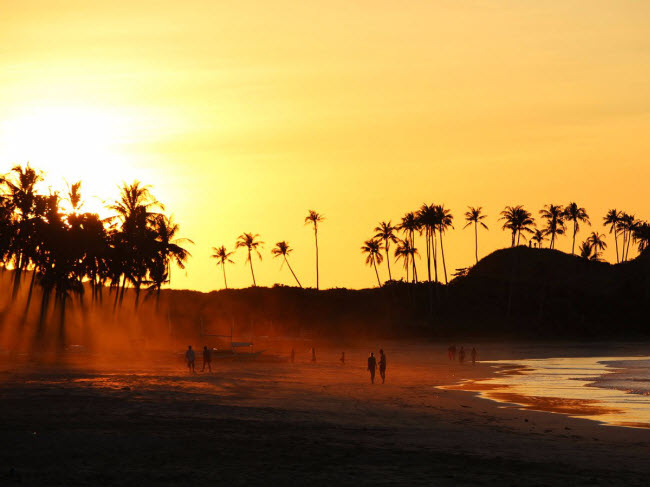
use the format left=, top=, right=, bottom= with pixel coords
left=0, top=164, right=192, bottom=341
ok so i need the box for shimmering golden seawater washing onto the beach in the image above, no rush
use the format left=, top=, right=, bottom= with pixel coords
left=454, top=357, right=650, bottom=428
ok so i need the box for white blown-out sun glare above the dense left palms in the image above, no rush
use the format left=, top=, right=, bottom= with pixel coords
left=0, top=106, right=131, bottom=216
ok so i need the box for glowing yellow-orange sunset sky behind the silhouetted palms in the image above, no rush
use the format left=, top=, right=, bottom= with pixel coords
left=0, top=0, right=650, bottom=291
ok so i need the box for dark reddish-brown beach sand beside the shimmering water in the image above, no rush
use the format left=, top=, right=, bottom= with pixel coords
left=0, top=343, right=650, bottom=486
